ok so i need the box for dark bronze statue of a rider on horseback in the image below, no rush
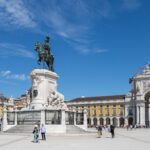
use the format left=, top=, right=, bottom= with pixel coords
left=35, top=36, right=54, bottom=71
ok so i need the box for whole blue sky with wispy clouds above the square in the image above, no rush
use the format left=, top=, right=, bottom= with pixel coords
left=0, top=0, right=150, bottom=99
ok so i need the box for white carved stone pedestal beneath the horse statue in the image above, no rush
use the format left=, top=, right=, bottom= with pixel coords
left=29, top=69, right=65, bottom=109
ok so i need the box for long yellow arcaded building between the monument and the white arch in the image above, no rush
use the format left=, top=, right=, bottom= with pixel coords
left=66, top=95, right=125, bottom=127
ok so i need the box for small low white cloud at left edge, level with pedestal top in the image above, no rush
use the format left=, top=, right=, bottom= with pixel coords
left=0, top=70, right=28, bottom=81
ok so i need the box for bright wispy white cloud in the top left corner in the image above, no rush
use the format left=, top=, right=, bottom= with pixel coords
left=0, top=0, right=36, bottom=28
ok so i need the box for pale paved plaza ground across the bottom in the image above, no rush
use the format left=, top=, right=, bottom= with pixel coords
left=0, top=129, right=150, bottom=150
